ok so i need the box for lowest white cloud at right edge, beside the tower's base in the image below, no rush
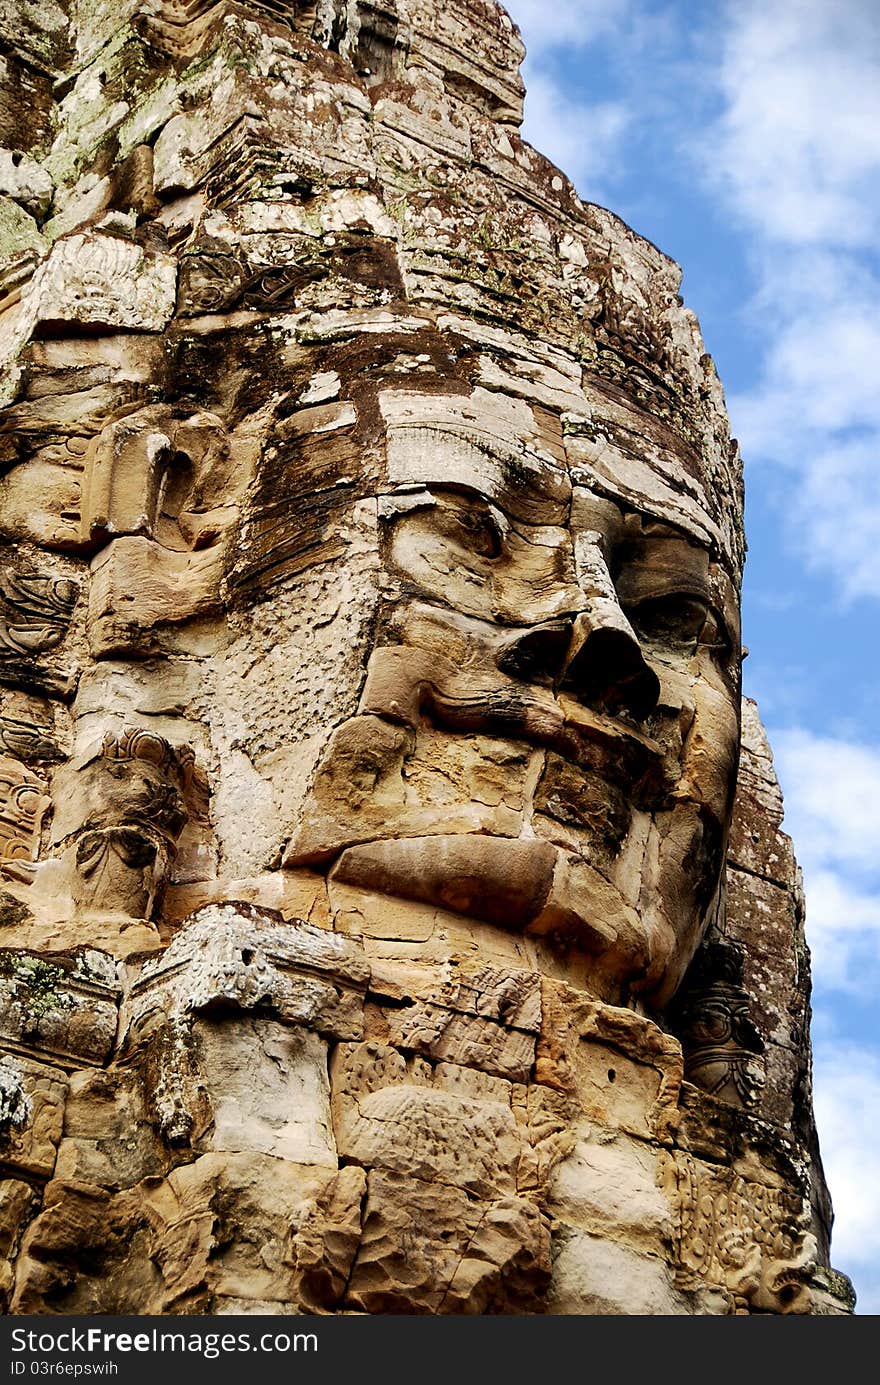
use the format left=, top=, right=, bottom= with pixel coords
left=813, top=1032, right=880, bottom=1313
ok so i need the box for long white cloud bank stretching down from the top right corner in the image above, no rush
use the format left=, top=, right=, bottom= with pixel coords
left=698, top=0, right=880, bottom=600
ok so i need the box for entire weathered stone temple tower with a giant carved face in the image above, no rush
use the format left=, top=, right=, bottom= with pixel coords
left=0, top=0, right=851, bottom=1314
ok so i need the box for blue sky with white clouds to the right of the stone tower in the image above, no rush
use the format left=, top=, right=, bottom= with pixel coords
left=507, top=0, right=880, bottom=1313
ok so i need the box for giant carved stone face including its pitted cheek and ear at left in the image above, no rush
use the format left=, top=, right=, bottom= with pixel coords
left=6, top=327, right=739, bottom=1006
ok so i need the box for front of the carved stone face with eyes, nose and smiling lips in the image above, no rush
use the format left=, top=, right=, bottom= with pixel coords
left=277, top=392, right=739, bottom=1003
